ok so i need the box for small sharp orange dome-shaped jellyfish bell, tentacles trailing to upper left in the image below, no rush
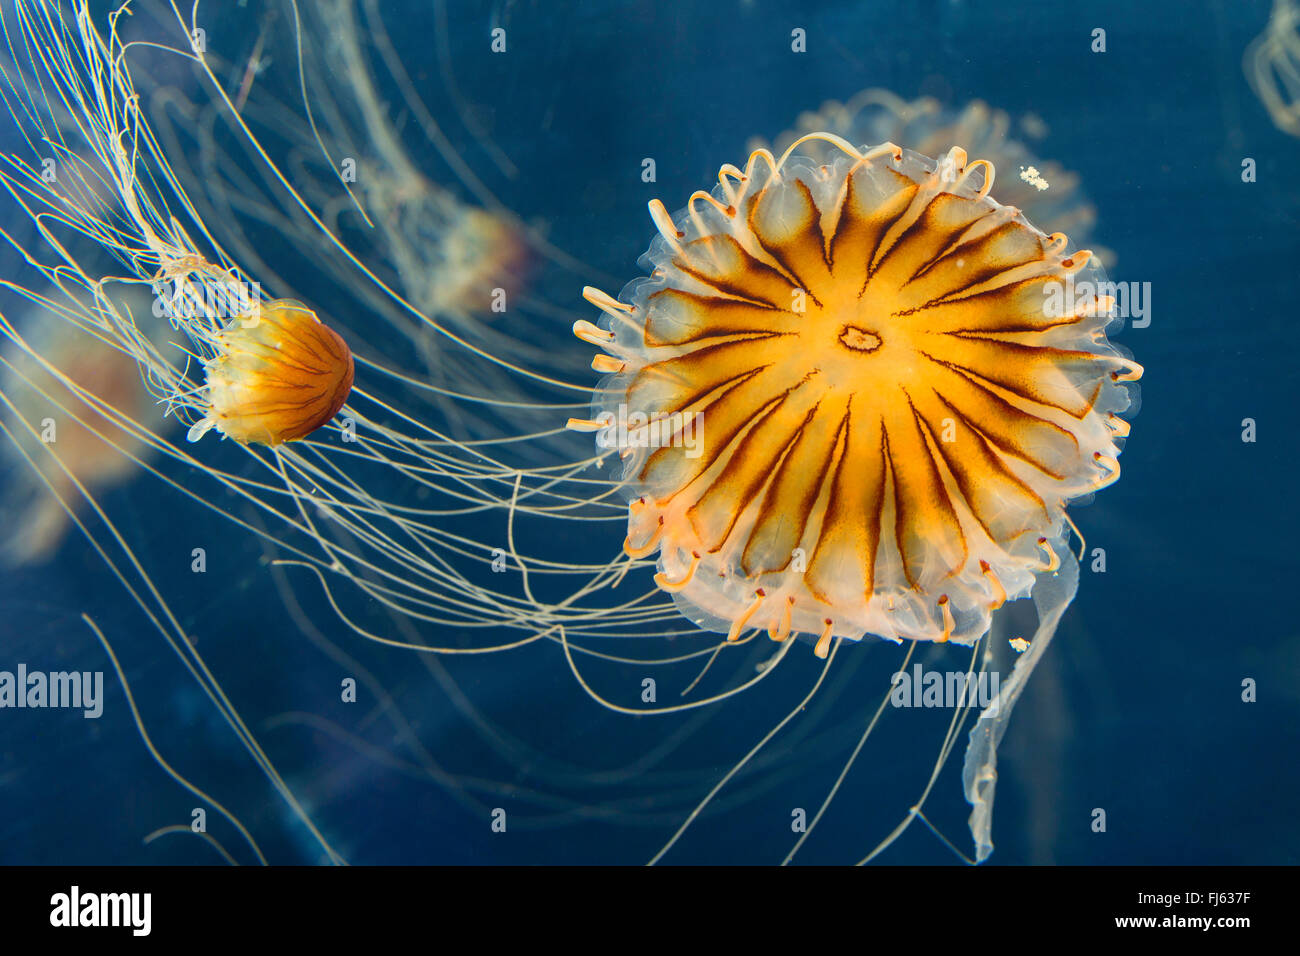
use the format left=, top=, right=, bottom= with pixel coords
left=187, top=299, right=354, bottom=445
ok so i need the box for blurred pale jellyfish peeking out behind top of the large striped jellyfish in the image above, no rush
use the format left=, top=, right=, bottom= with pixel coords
left=751, top=90, right=1114, bottom=268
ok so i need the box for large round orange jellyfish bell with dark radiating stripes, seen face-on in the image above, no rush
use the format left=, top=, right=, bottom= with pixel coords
left=569, top=134, right=1141, bottom=656
